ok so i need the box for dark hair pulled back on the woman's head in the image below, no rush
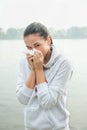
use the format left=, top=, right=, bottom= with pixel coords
left=24, top=22, right=53, bottom=44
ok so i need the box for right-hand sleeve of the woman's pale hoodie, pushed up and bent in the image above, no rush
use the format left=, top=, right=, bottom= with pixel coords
left=36, top=61, right=72, bottom=109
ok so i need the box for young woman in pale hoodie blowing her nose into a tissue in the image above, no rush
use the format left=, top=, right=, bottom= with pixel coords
left=16, top=22, right=72, bottom=130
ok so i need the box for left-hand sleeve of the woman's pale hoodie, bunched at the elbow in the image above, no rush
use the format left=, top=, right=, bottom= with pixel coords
left=16, top=59, right=33, bottom=105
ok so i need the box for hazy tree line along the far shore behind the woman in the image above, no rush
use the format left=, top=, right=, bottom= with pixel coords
left=0, top=27, right=87, bottom=40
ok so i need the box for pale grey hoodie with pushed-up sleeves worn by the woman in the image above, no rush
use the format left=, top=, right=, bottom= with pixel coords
left=16, top=45, right=72, bottom=130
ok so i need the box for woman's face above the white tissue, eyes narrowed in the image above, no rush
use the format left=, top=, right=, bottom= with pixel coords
left=24, top=33, right=51, bottom=57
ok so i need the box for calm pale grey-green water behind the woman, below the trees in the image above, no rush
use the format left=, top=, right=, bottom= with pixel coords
left=0, top=40, right=87, bottom=130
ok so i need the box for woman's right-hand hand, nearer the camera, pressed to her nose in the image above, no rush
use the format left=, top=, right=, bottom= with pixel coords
left=33, top=50, right=44, bottom=70
